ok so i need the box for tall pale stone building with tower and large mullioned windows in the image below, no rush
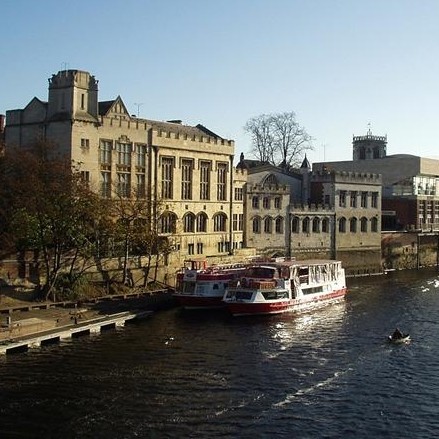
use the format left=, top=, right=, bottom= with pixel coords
left=5, top=70, right=251, bottom=282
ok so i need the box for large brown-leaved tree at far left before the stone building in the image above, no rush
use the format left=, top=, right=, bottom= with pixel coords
left=0, top=142, right=108, bottom=300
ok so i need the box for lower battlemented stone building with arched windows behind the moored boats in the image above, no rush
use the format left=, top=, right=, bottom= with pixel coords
left=240, top=157, right=381, bottom=274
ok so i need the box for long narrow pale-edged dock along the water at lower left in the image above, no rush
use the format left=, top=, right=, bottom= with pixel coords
left=0, top=310, right=153, bottom=355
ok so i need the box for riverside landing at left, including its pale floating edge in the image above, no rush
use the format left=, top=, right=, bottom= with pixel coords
left=0, top=290, right=172, bottom=355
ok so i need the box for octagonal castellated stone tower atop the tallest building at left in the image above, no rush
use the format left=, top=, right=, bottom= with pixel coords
left=47, top=70, right=98, bottom=121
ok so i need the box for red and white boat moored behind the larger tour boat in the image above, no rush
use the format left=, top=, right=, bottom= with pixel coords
left=174, top=261, right=246, bottom=309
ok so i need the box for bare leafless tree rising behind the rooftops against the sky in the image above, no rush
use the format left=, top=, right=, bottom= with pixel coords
left=244, top=111, right=314, bottom=170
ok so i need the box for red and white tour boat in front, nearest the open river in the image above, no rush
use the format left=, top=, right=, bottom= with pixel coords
left=223, top=259, right=347, bottom=316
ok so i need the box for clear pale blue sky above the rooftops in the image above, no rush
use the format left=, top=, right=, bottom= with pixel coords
left=0, top=0, right=439, bottom=162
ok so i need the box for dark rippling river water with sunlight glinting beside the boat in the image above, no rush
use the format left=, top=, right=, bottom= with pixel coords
left=0, top=270, right=439, bottom=439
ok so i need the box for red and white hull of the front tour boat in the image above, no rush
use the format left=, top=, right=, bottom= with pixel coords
left=226, top=288, right=347, bottom=317
